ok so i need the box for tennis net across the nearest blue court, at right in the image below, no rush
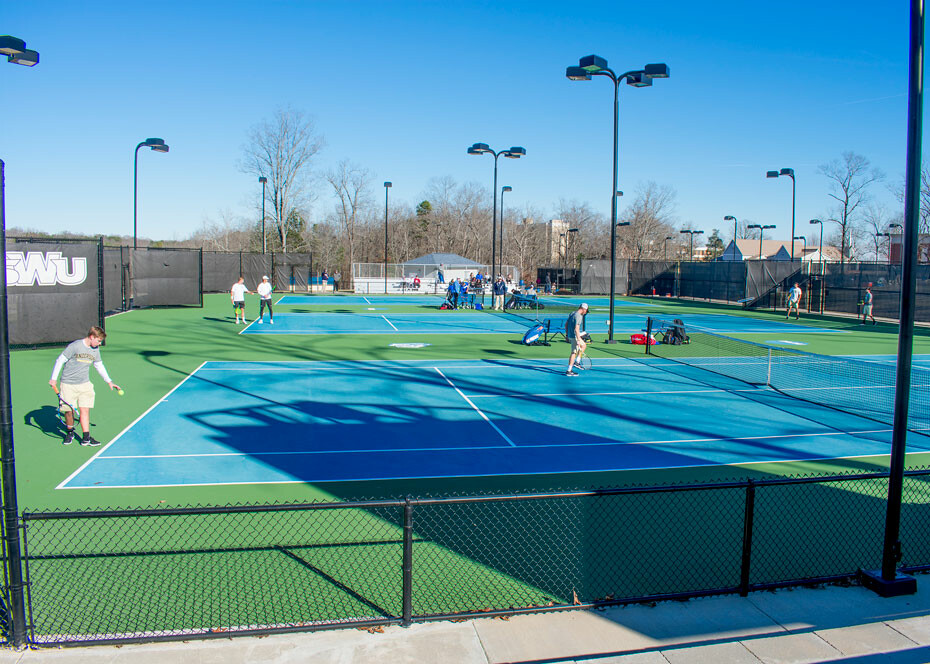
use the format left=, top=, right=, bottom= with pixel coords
left=646, top=317, right=930, bottom=435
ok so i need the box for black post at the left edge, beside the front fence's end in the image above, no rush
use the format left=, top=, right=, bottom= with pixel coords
left=0, top=159, right=26, bottom=648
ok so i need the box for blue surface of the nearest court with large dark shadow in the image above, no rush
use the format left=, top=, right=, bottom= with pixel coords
left=59, top=358, right=930, bottom=488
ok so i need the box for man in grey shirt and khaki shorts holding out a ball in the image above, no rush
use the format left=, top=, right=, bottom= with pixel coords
left=48, top=325, right=123, bottom=447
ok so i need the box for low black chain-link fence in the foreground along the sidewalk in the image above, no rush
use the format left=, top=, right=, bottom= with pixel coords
left=14, top=466, right=930, bottom=646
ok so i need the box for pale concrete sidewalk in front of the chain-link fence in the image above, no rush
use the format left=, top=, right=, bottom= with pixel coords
left=0, top=576, right=930, bottom=664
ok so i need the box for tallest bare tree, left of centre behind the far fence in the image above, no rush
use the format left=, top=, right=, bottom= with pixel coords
left=240, top=108, right=323, bottom=251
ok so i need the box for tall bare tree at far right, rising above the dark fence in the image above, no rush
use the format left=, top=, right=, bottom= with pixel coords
left=818, top=152, right=885, bottom=263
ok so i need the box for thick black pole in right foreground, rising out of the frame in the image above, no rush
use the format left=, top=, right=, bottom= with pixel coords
left=879, top=0, right=924, bottom=595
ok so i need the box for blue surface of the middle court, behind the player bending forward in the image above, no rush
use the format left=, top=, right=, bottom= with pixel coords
left=240, top=309, right=839, bottom=334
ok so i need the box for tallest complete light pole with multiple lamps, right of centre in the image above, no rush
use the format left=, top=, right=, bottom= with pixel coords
left=565, top=55, right=669, bottom=344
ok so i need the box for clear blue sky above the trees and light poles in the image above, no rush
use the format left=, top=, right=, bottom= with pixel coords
left=0, top=0, right=912, bottom=245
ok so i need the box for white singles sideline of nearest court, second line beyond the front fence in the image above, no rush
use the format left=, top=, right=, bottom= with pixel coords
left=92, top=426, right=893, bottom=459
